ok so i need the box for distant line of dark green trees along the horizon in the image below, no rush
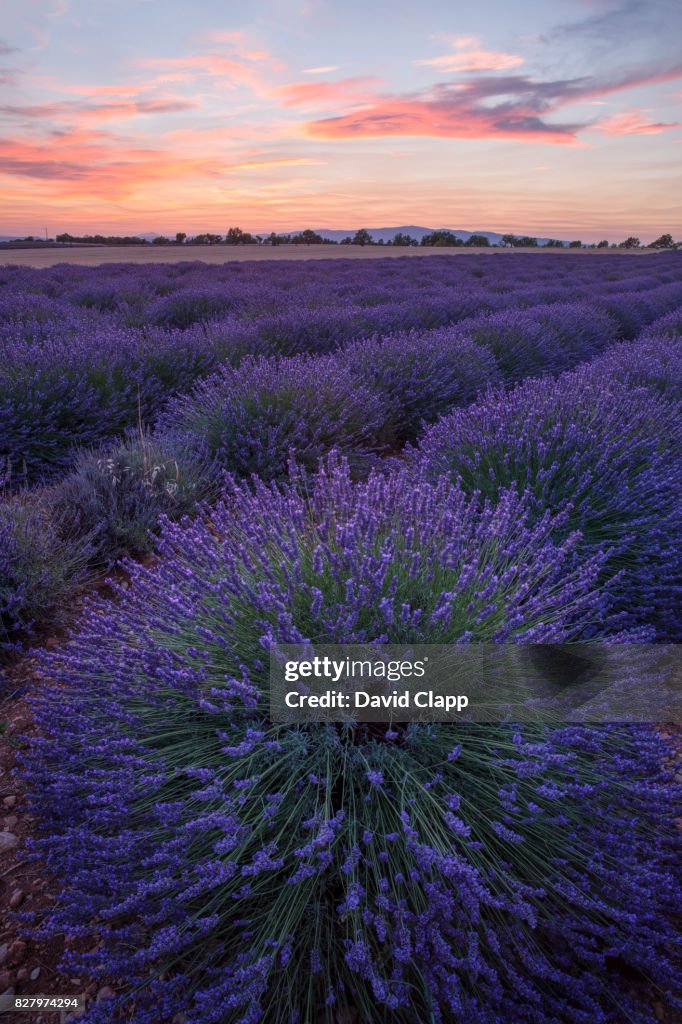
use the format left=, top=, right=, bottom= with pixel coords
left=46, top=227, right=682, bottom=249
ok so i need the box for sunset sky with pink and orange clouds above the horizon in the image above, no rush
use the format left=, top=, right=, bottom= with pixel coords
left=0, top=0, right=682, bottom=242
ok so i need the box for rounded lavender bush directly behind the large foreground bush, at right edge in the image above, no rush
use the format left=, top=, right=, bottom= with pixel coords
left=411, top=366, right=682, bottom=638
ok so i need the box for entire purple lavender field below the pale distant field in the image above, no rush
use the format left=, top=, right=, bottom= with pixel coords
left=0, top=252, right=682, bottom=1024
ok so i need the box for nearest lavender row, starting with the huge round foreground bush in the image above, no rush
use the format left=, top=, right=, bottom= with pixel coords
left=27, top=314, right=682, bottom=1024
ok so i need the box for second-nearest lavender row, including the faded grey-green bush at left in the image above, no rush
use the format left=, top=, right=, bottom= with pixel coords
left=0, top=284, right=680, bottom=644
